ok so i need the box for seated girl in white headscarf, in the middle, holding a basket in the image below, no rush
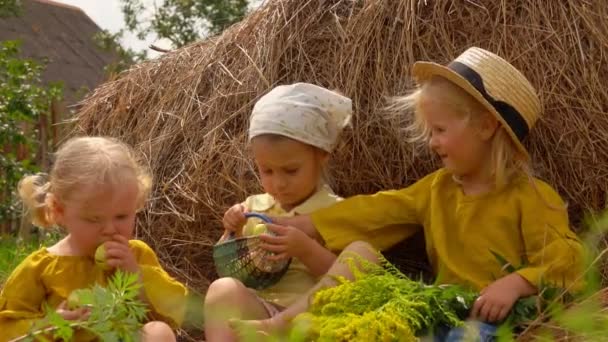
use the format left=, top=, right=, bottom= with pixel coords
left=205, top=83, right=352, bottom=342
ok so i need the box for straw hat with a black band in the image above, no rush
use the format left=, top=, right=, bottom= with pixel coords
left=412, top=47, right=541, bottom=158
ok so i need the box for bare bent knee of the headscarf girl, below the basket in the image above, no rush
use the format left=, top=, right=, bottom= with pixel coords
left=205, top=278, right=269, bottom=342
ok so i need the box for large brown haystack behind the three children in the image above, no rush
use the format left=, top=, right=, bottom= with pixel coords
left=76, top=0, right=608, bottom=289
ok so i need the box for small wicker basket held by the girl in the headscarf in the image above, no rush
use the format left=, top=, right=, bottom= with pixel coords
left=213, top=213, right=291, bottom=290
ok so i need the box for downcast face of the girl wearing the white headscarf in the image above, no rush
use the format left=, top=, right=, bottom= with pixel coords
left=251, top=136, right=328, bottom=211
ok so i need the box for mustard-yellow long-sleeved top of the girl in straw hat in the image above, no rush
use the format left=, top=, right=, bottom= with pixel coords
left=312, top=169, right=582, bottom=290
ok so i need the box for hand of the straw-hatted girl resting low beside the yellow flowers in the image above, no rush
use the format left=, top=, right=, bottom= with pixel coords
left=471, top=273, right=536, bottom=323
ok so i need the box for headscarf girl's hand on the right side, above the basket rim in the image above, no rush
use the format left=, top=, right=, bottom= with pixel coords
left=260, top=223, right=313, bottom=260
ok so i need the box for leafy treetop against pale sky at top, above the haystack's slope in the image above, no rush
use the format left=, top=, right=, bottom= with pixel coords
left=121, top=0, right=248, bottom=47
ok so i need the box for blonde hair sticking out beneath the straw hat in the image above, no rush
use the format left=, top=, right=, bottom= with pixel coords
left=389, top=76, right=531, bottom=187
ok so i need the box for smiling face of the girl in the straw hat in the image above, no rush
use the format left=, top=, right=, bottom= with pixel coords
left=418, top=92, right=497, bottom=179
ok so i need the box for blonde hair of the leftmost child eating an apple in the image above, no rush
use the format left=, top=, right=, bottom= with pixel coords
left=18, top=137, right=152, bottom=227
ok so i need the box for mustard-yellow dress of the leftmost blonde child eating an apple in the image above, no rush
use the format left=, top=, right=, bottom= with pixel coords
left=0, top=240, right=188, bottom=341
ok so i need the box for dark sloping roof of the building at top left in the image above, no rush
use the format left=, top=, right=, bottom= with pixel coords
left=0, top=0, right=116, bottom=104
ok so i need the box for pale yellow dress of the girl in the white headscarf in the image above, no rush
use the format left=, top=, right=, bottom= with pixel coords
left=243, top=186, right=341, bottom=307
